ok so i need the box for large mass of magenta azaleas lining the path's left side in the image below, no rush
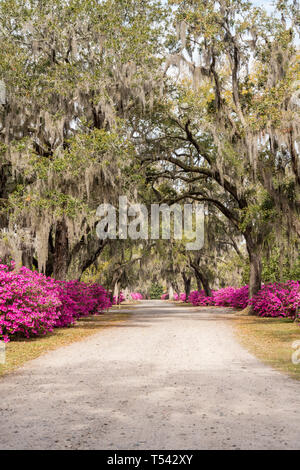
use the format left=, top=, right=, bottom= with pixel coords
left=0, top=265, right=111, bottom=342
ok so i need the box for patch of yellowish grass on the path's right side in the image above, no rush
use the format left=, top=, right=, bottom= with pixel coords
left=233, top=316, right=300, bottom=380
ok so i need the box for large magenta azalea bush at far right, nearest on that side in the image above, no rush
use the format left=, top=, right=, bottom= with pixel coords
left=249, top=281, right=300, bottom=317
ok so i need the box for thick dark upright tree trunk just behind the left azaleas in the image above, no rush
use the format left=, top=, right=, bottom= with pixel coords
left=53, top=219, right=69, bottom=280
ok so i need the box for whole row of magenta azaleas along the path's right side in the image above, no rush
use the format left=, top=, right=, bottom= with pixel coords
left=188, top=281, right=300, bottom=317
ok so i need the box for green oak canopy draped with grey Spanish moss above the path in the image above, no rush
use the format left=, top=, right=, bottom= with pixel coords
left=0, top=0, right=300, bottom=296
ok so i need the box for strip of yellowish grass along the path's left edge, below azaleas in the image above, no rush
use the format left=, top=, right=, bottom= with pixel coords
left=0, top=304, right=130, bottom=377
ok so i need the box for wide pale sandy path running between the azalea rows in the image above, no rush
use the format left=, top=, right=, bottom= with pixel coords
left=0, top=301, right=300, bottom=449
